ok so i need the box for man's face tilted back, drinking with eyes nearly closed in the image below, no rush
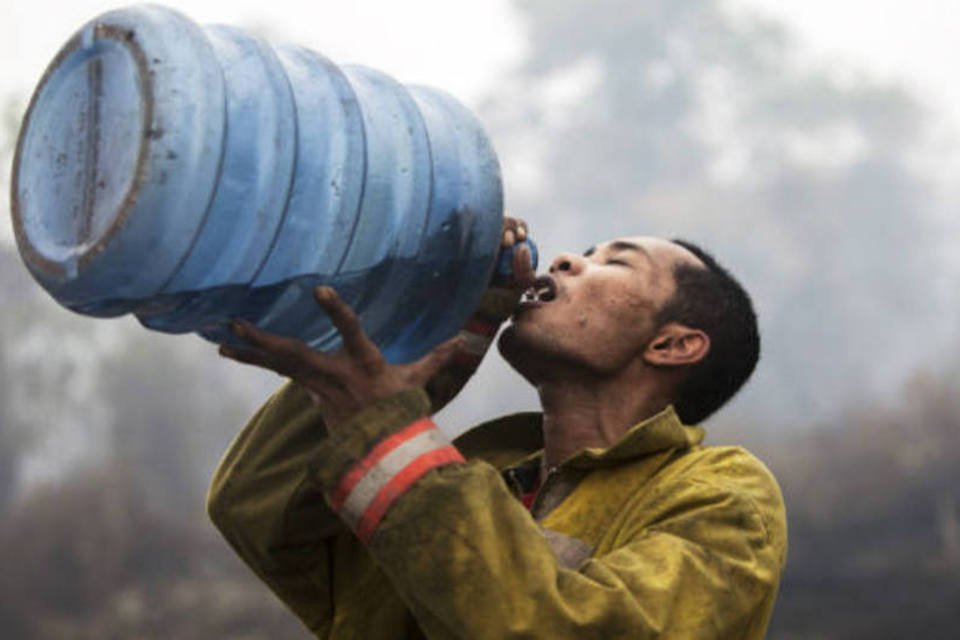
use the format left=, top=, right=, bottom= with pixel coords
left=499, top=237, right=701, bottom=383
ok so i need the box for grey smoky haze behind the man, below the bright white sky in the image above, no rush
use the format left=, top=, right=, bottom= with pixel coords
left=0, top=0, right=960, bottom=639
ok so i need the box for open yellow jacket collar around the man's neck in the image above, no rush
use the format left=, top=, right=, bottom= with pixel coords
left=455, top=405, right=704, bottom=469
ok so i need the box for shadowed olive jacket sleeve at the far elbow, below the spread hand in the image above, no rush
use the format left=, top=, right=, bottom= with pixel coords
left=207, top=383, right=343, bottom=637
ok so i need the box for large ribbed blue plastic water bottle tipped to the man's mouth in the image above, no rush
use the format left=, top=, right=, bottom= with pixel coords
left=12, top=6, right=532, bottom=361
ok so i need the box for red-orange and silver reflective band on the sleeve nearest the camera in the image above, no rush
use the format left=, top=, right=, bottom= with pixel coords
left=330, top=418, right=464, bottom=542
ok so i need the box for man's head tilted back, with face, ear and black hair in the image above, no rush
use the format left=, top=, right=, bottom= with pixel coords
left=500, top=237, right=759, bottom=423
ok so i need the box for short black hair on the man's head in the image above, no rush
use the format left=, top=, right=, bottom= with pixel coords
left=656, top=239, right=760, bottom=424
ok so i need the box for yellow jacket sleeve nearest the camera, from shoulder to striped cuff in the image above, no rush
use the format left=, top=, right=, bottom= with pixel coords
left=319, top=398, right=781, bottom=639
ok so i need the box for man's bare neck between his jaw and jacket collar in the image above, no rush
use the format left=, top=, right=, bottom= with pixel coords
left=537, top=376, right=670, bottom=469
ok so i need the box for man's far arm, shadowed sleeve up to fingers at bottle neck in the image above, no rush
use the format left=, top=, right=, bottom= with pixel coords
left=207, top=218, right=532, bottom=637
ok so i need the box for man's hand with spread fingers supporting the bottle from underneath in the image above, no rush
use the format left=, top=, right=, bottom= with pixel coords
left=220, top=287, right=463, bottom=432
